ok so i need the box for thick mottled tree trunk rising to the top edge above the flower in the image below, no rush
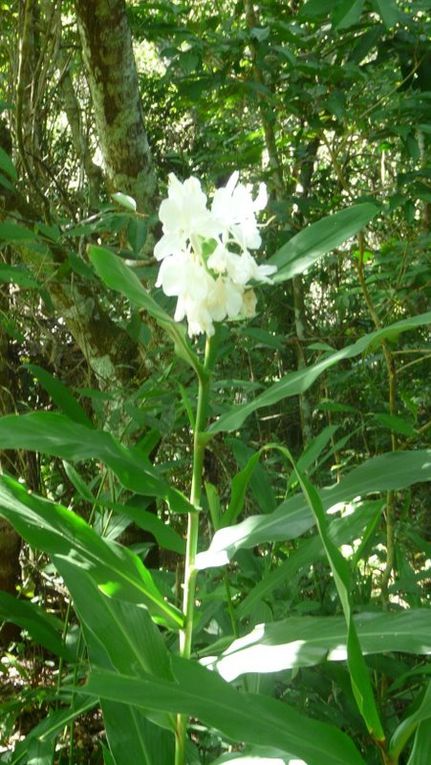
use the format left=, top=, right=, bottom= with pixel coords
left=75, top=0, right=156, bottom=213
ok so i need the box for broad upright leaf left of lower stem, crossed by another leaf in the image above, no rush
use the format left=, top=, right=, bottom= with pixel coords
left=59, top=560, right=175, bottom=765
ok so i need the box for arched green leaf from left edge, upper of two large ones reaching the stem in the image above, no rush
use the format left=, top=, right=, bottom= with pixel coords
left=0, top=412, right=190, bottom=512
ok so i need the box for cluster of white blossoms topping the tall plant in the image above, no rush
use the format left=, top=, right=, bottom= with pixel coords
left=154, top=172, right=277, bottom=336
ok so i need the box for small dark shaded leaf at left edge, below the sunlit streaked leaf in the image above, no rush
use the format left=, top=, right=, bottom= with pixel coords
left=0, top=591, right=73, bottom=661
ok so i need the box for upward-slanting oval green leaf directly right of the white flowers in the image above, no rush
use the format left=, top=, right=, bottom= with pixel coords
left=269, top=202, right=379, bottom=284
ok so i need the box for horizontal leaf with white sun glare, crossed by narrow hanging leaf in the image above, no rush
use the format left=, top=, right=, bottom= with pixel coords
left=211, top=608, right=431, bottom=682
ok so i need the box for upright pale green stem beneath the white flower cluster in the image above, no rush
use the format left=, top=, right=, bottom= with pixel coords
left=175, top=338, right=210, bottom=765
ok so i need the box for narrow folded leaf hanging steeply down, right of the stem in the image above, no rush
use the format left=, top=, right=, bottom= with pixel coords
left=284, top=449, right=385, bottom=742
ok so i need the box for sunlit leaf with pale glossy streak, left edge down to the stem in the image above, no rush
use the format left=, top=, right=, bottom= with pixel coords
left=0, top=476, right=183, bottom=628
